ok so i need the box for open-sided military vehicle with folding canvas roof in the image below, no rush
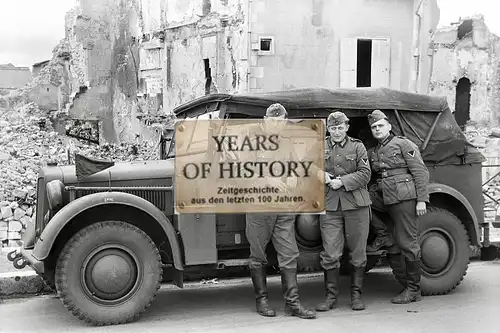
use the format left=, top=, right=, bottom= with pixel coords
left=9, top=88, right=492, bottom=325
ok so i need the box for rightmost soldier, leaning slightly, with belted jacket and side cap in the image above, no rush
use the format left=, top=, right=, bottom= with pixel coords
left=367, top=110, right=429, bottom=304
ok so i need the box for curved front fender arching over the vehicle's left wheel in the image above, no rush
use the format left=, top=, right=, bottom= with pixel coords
left=33, top=192, right=183, bottom=270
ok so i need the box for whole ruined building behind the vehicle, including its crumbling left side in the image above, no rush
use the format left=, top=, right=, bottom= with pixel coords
left=45, top=0, right=439, bottom=142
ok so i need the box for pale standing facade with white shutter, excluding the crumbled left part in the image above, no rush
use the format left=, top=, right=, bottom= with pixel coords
left=146, top=0, right=439, bottom=112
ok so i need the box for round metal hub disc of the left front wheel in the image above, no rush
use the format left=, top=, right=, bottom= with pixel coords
left=84, top=248, right=138, bottom=300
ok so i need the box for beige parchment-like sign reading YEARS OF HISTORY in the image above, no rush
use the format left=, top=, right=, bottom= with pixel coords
left=174, top=119, right=325, bottom=214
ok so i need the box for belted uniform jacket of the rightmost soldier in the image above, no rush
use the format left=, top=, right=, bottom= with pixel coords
left=368, top=134, right=429, bottom=205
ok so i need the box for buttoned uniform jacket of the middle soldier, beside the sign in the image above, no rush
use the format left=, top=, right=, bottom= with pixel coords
left=316, top=136, right=371, bottom=211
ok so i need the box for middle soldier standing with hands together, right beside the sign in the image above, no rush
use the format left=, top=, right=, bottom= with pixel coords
left=316, top=112, right=371, bottom=311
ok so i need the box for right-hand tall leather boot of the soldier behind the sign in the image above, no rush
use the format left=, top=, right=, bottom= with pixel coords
left=280, top=269, right=316, bottom=319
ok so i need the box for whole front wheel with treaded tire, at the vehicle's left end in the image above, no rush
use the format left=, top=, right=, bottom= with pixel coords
left=55, top=221, right=163, bottom=326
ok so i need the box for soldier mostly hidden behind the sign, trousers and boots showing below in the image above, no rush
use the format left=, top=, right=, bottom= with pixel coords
left=246, top=104, right=316, bottom=319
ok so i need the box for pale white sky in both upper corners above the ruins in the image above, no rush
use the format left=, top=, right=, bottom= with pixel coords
left=0, top=0, right=500, bottom=66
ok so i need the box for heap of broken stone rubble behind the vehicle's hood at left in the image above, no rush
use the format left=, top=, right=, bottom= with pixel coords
left=0, top=103, right=159, bottom=247
